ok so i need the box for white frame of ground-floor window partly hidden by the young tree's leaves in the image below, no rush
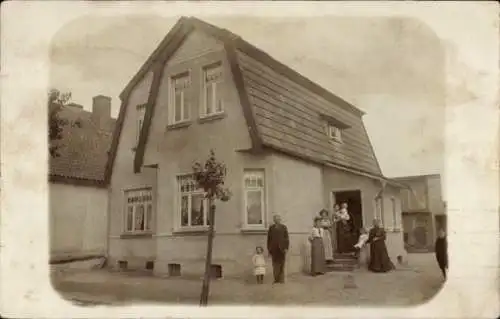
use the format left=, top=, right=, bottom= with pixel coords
left=175, top=173, right=210, bottom=232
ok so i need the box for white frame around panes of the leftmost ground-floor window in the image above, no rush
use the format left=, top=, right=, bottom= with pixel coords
left=122, top=186, right=155, bottom=234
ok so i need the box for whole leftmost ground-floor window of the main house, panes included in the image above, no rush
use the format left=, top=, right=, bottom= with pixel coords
left=125, top=188, right=153, bottom=232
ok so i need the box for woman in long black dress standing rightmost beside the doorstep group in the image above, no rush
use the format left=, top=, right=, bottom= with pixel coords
left=368, top=219, right=395, bottom=272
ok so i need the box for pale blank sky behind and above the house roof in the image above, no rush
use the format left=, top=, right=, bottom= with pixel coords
left=50, top=5, right=496, bottom=177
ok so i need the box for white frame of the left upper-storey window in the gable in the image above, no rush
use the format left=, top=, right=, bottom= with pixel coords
left=168, top=70, right=192, bottom=125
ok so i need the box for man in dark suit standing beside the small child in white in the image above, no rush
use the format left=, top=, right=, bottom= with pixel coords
left=267, top=215, right=290, bottom=284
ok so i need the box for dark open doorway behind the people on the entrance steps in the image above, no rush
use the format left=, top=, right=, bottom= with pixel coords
left=332, top=190, right=363, bottom=253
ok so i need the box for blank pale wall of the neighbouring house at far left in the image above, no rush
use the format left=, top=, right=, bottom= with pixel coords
left=49, top=183, right=108, bottom=260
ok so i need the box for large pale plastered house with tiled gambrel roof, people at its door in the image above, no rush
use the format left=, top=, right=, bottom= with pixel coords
left=108, top=17, right=405, bottom=275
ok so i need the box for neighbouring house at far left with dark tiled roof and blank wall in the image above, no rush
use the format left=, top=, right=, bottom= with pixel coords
left=49, top=95, right=115, bottom=262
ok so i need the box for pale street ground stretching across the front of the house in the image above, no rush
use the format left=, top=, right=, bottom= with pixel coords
left=53, top=254, right=443, bottom=306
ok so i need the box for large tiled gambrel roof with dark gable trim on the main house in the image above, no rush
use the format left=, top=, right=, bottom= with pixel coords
left=108, top=17, right=383, bottom=182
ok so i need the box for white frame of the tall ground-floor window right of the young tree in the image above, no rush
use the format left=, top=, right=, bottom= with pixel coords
left=242, top=168, right=267, bottom=230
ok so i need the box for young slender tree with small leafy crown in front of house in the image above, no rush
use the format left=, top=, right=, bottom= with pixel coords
left=193, top=150, right=231, bottom=306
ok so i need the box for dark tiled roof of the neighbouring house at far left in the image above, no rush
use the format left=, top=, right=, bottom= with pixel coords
left=49, top=106, right=115, bottom=187
